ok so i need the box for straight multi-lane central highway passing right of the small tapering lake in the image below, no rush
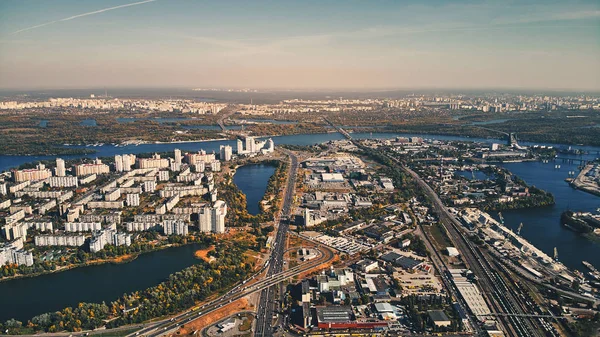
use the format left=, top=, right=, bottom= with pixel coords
left=254, top=150, right=298, bottom=337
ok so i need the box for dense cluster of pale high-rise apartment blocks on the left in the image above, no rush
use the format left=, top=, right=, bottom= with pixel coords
left=0, top=146, right=241, bottom=263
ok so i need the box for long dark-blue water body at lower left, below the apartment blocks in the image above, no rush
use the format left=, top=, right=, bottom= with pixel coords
left=0, top=244, right=201, bottom=322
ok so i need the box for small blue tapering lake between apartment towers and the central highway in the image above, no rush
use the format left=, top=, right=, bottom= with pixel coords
left=233, top=164, right=277, bottom=215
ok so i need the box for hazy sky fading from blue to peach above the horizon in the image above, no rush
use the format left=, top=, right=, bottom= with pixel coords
left=0, top=0, right=600, bottom=91
